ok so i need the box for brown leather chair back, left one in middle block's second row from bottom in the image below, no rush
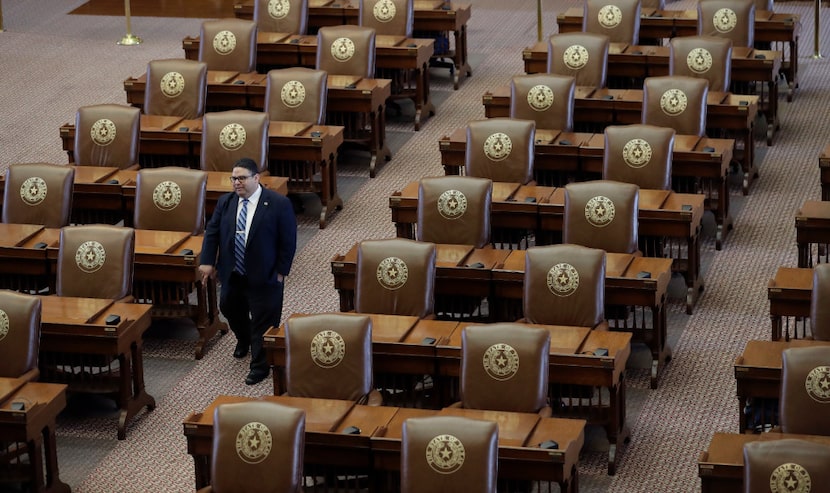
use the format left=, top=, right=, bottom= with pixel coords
left=285, top=313, right=372, bottom=401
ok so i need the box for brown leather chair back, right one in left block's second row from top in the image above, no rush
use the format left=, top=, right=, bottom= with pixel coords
left=317, top=25, right=375, bottom=78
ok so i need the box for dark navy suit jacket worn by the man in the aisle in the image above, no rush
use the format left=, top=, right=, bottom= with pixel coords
left=200, top=188, right=297, bottom=286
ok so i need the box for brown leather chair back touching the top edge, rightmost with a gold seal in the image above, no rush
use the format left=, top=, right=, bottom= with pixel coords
left=697, top=0, right=755, bottom=47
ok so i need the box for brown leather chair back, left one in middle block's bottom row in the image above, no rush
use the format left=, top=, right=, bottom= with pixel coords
left=199, top=401, right=305, bottom=493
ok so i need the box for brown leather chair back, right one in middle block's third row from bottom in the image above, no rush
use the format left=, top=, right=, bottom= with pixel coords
left=522, top=244, right=605, bottom=327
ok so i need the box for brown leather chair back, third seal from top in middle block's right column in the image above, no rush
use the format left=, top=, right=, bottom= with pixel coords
left=642, top=75, right=709, bottom=137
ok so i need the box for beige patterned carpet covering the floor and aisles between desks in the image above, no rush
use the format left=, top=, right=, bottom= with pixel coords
left=0, top=0, right=830, bottom=493
